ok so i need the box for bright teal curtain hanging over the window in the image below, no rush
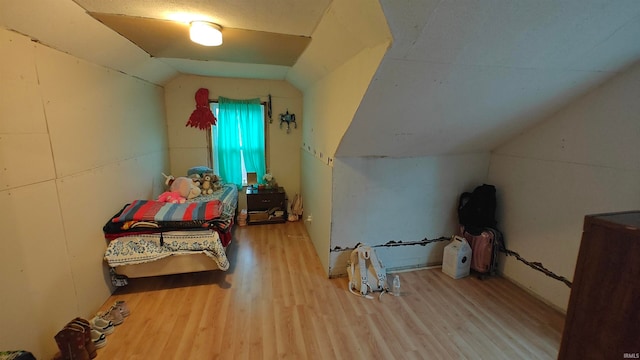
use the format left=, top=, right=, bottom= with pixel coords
left=216, top=96, right=266, bottom=186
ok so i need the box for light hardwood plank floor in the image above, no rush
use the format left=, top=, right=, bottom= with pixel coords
left=98, top=222, right=564, bottom=360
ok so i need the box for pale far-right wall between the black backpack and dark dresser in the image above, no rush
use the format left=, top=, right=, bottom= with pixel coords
left=488, top=60, right=640, bottom=310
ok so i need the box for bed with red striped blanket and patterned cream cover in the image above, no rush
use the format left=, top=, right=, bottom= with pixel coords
left=103, top=184, right=238, bottom=278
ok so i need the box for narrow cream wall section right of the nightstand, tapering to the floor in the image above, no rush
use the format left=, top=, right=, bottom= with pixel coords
left=302, top=43, right=387, bottom=273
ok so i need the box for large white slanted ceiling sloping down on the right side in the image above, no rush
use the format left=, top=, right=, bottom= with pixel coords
left=336, top=0, right=640, bottom=157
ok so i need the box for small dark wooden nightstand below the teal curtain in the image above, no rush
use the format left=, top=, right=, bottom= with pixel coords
left=247, top=186, right=287, bottom=225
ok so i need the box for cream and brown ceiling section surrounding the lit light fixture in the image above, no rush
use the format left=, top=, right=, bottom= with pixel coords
left=74, top=0, right=329, bottom=78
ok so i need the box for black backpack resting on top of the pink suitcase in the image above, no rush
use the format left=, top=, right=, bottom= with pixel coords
left=458, top=184, right=497, bottom=235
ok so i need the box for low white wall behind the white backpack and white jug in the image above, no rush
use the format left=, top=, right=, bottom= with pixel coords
left=330, top=153, right=489, bottom=275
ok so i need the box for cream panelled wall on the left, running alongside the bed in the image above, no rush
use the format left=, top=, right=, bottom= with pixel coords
left=0, top=30, right=168, bottom=359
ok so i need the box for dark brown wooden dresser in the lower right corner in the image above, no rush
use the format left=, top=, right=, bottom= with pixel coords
left=558, top=211, right=640, bottom=360
